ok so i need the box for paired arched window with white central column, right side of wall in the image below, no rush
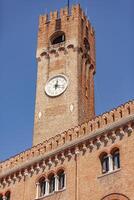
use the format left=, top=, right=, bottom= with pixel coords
left=100, top=148, right=120, bottom=174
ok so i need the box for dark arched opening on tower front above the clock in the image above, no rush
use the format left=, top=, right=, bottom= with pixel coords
left=50, top=31, right=65, bottom=45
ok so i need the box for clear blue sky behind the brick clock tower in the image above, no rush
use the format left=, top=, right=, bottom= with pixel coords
left=0, top=0, right=134, bottom=160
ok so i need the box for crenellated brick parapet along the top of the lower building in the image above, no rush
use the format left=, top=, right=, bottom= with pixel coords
left=0, top=101, right=134, bottom=174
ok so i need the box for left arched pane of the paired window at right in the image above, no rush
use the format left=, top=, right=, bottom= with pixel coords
left=100, top=153, right=109, bottom=174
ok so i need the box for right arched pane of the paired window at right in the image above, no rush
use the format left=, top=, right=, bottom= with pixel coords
left=112, top=149, right=120, bottom=170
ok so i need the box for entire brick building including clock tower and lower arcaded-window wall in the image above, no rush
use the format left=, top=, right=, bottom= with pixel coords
left=0, top=5, right=134, bottom=200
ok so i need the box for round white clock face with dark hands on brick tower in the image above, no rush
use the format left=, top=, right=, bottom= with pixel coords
left=45, top=74, right=68, bottom=97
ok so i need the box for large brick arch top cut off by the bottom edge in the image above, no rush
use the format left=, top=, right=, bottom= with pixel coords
left=101, top=193, right=130, bottom=200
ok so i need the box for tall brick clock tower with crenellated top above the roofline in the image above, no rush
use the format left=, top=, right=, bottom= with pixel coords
left=33, top=5, right=95, bottom=145
